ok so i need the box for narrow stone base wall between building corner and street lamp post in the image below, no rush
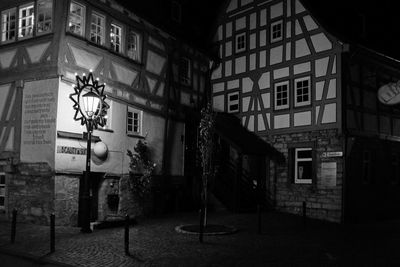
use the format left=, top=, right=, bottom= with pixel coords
left=54, top=175, right=80, bottom=226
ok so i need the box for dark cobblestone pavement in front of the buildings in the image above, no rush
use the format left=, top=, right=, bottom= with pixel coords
left=0, top=212, right=400, bottom=267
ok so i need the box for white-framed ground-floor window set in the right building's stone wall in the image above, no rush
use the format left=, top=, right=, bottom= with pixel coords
left=294, top=147, right=313, bottom=184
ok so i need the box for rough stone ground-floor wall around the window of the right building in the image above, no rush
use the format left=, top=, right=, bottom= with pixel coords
left=266, top=130, right=344, bottom=222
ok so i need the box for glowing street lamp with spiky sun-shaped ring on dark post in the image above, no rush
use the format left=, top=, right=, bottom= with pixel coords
left=69, top=72, right=110, bottom=233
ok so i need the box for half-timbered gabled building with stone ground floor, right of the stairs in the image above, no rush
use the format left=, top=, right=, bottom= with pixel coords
left=212, top=0, right=400, bottom=222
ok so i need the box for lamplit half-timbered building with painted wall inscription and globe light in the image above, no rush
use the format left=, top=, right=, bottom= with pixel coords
left=0, top=0, right=209, bottom=225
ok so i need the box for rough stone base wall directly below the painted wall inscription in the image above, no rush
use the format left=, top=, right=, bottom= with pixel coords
left=8, top=163, right=54, bottom=225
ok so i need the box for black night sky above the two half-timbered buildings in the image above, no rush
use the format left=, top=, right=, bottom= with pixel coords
left=119, top=0, right=400, bottom=59
